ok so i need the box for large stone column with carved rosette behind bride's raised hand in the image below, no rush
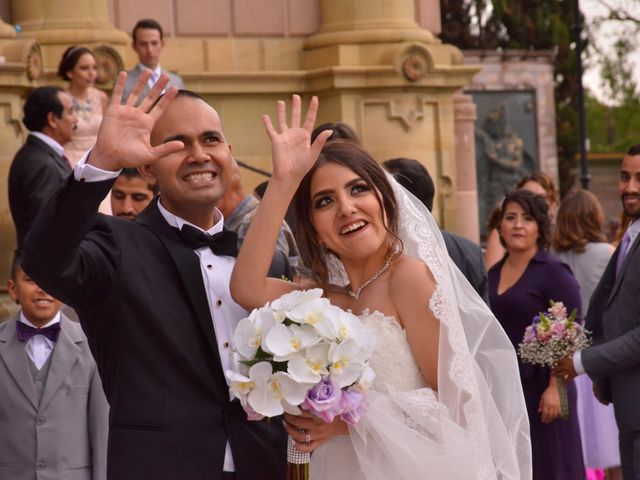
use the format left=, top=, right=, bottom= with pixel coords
left=304, top=0, right=477, bottom=231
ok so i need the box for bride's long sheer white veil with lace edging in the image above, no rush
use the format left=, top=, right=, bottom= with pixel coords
left=311, top=175, right=532, bottom=480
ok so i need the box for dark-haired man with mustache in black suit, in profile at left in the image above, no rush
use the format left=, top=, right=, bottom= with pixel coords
left=8, top=87, right=78, bottom=248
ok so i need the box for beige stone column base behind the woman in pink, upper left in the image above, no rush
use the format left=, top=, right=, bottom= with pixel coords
left=11, top=0, right=129, bottom=77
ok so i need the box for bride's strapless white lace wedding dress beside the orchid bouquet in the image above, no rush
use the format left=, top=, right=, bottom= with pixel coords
left=310, top=312, right=497, bottom=480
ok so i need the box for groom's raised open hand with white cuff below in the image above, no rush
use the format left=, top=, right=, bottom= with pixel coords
left=87, top=70, right=184, bottom=171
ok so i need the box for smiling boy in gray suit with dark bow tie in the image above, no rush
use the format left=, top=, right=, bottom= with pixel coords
left=0, top=252, right=109, bottom=480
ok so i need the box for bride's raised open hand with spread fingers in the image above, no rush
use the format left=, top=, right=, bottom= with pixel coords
left=262, top=95, right=331, bottom=186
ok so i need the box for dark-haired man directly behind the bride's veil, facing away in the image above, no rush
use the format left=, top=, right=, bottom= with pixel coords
left=382, top=158, right=489, bottom=304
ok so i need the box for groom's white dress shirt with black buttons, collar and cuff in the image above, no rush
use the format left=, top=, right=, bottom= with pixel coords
left=73, top=154, right=242, bottom=472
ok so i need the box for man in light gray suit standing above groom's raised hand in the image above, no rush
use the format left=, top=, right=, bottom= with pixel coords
left=122, top=19, right=184, bottom=104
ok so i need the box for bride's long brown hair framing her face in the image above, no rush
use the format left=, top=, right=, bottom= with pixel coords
left=294, top=140, right=402, bottom=288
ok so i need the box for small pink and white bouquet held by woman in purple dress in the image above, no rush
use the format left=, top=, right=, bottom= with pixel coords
left=518, top=300, right=591, bottom=418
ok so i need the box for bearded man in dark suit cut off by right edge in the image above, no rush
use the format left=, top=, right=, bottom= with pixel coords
left=554, top=144, right=640, bottom=480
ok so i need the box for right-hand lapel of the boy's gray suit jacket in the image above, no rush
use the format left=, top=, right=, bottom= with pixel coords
left=40, top=315, right=86, bottom=409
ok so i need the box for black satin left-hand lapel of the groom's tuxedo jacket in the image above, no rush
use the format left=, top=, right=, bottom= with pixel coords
left=138, top=199, right=225, bottom=382
